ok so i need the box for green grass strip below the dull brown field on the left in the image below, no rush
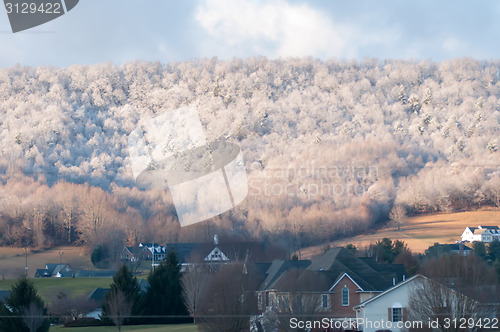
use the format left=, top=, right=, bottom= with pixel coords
left=0, top=278, right=113, bottom=303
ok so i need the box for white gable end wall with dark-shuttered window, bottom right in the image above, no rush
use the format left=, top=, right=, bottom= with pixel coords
left=354, top=275, right=425, bottom=332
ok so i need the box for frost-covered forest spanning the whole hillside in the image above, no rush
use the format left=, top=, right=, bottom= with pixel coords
left=0, top=57, right=500, bottom=250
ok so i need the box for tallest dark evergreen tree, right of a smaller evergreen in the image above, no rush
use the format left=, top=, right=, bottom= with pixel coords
left=146, top=249, right=189, bottom=323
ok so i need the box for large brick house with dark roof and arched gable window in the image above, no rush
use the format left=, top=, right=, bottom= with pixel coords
left=257, top=247, right=406, bottom=319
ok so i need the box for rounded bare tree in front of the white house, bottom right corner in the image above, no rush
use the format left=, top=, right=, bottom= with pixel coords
left=408, top=254, right=498, bottom=331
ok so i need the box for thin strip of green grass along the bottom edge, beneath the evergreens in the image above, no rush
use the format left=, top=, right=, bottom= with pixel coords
left=50, top=324, right=198, bottom=332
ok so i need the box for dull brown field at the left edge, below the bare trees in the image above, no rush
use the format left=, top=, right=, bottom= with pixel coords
left=0, top=247, right=92, bottom=279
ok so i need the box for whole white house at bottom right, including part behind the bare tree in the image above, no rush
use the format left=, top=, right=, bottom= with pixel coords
left=354, top=275, right=499, bottom=332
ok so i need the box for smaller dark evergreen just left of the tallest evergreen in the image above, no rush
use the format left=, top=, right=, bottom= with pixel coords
left=102, top=264, right=142, bottom=323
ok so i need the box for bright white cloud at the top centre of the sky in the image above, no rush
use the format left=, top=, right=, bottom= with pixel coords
left=195, top=0, right=356, bottom=58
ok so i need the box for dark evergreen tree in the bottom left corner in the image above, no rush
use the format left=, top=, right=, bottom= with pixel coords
left=0, top=277, right=50, bottom=332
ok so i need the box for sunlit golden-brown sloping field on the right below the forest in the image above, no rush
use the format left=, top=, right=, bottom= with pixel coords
left=301, top=208, right=500, bottom=258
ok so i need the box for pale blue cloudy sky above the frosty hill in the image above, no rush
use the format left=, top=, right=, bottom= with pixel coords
left=0, top=0, right=500, bottom=67
